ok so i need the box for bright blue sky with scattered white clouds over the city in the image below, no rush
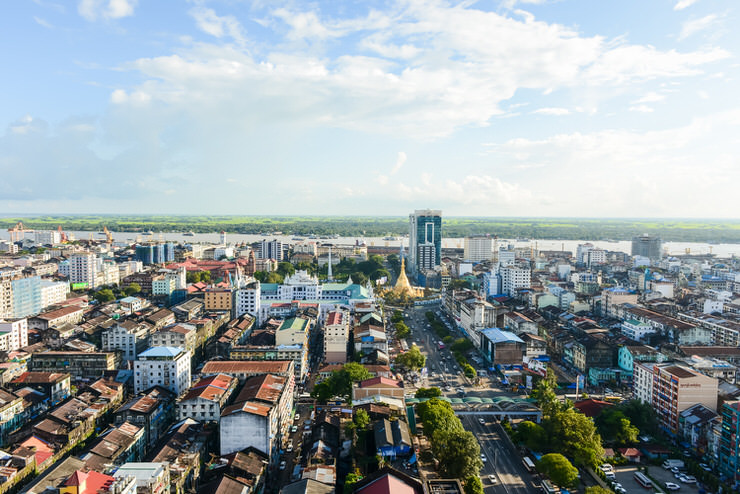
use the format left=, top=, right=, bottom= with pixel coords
left=0, top=0, right=740, bottom=218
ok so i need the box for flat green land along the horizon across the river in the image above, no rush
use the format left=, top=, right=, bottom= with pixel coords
left=5, top=215, right=740, bottom=242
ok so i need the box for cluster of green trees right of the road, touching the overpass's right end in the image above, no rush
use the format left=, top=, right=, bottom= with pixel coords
left=512, top=372, right=604, bottom=467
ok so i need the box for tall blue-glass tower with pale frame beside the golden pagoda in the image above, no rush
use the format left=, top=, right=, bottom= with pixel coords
left=409, top=209, right=442, bottom=272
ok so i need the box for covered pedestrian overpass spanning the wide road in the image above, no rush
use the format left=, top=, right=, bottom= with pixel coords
left=406, top=396, right=542, bottom=423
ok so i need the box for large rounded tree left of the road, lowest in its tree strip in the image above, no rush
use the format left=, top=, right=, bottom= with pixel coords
left=432, top=429, right=483, bottom=479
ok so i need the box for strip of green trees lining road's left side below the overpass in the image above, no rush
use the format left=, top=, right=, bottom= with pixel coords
left=416, top=398, right=483, bottom=482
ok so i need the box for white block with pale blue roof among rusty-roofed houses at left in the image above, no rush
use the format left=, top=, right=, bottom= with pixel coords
left=134, top=347, right=190, bottom=396
